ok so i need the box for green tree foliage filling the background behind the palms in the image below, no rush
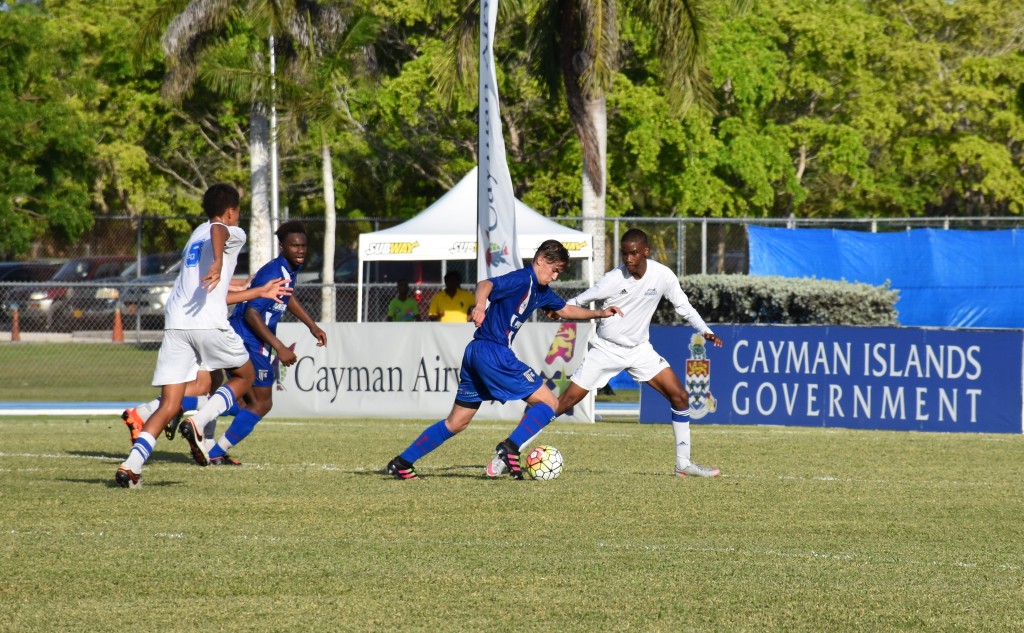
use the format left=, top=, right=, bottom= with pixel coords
left=0, top=0, right=1024, bottom=258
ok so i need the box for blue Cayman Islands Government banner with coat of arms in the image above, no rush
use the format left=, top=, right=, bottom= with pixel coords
left=640, top=326, right=1024, bottom=433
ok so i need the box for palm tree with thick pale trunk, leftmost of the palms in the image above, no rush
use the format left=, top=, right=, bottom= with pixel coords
left=140, top=0, right=343, bottom=269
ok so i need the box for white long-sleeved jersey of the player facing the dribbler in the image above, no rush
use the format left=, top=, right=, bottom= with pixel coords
left=569, top=259, right=711, bottom=347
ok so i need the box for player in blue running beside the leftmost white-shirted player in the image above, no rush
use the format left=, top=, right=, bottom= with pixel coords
left=194, top=220, right=327, bottom=466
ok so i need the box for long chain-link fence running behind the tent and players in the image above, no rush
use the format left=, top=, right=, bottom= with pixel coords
left=0, top=212, right=1024, bottom=402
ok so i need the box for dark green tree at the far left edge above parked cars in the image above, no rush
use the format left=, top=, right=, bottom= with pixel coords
left=0, top=4, right=98, bottom=258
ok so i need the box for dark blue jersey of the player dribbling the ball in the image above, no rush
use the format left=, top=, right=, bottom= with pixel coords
left=473, top=266, right=565, bottom=347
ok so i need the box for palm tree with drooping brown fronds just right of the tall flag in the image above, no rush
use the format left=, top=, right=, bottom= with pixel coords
left=439, top=0, right=720, bottom=271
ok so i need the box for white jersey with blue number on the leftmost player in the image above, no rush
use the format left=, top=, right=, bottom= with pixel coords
left=165, top=222, right=246, bottom=330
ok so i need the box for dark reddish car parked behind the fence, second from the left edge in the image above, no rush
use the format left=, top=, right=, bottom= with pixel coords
left=9, top=255, right=135, bottom=331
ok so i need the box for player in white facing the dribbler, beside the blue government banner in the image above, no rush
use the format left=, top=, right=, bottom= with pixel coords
left=486, top=228, right=722, bottom=477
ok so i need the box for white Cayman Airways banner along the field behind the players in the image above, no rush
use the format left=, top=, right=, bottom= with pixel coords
left=270, top=322, right=594, bottom=422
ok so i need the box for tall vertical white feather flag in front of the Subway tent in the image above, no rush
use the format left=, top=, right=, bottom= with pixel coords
left=476, top=0, right=522, bottom=281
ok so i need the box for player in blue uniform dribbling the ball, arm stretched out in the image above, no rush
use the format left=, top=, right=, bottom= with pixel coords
left=387, top=240, right=623, bottom=479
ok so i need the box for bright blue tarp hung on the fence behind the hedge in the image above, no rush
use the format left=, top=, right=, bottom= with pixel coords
left=748, top=226, right=1024, bottom=328
